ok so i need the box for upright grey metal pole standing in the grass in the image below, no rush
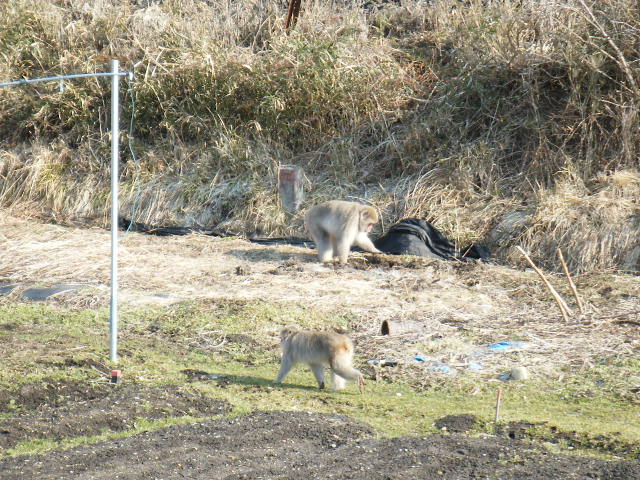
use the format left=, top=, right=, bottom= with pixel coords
left=109, top=60, right=120, bottom=362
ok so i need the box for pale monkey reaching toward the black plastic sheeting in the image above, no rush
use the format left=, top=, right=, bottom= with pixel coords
left=304, top=200, right=382, bottom=264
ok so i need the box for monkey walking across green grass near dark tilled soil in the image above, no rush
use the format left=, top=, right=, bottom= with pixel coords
left=275, top=328, right=364, bottom=393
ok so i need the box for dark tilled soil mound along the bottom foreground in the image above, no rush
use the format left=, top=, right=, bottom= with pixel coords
left=0, top=412, right=640, bottom=480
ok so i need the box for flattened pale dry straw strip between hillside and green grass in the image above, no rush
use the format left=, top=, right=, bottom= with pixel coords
left=0, top=212, right=640, bottom=395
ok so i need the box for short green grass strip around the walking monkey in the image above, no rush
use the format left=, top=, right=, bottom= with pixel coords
left=0, top=301, right=640, bottom=455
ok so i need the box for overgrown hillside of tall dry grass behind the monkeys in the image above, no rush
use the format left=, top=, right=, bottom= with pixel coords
left=0, top=0, right=640, bottom=271
